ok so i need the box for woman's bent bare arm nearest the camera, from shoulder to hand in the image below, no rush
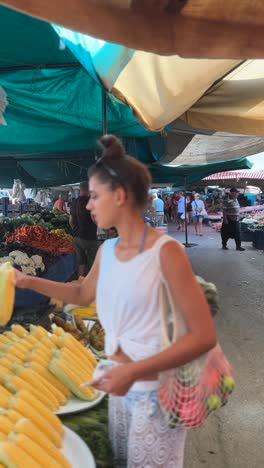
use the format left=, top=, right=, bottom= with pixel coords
left=92, top=241, right=216, bottom=395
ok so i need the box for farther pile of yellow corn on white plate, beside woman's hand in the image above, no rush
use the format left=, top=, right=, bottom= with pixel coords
left=0, top=325, right=98, bottom=411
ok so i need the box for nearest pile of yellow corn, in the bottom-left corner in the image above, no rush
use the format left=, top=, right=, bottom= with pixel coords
left=0, top=386, right=72, bottom=468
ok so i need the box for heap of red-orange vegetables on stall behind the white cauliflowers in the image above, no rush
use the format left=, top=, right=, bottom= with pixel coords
left=6, top=225, right=74, bottom=255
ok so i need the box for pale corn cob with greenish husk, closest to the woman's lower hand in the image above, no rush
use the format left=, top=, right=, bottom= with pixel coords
left=49, top=358, right=98, bottom=401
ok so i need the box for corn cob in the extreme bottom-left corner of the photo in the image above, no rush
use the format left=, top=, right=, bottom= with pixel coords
left=0, top=440, right=39, bottom=468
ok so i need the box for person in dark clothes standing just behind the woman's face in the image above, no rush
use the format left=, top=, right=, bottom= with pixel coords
left=69, top=181, right=100, bottom=276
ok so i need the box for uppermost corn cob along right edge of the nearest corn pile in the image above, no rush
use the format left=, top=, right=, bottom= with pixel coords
left=15, top=390, right=64, bottom=436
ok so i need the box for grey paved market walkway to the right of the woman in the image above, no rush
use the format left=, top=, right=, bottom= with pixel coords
left=170, top=228, right=264, bottom=468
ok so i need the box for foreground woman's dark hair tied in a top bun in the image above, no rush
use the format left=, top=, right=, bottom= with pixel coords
left=88, top=135, right=151, bottom=209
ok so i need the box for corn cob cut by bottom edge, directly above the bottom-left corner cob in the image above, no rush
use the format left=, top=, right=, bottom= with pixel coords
left=8, top=433, right=64, bottom=468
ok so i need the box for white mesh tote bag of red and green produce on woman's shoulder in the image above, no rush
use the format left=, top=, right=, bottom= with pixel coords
left=158, top=276, right=235, bottom=428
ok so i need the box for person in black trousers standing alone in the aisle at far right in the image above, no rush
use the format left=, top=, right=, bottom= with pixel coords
left=221, top=187, right=245, bottom=252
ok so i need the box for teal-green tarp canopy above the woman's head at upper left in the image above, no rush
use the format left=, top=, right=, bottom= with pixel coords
left=0, top=6, right=254, bottom=187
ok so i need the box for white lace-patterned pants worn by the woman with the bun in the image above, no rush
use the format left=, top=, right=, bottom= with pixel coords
left=109, top=391, right=186, bottom=468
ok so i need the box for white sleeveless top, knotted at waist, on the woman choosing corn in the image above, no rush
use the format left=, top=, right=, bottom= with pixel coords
left=96, top=235, right=177, bottom=361
